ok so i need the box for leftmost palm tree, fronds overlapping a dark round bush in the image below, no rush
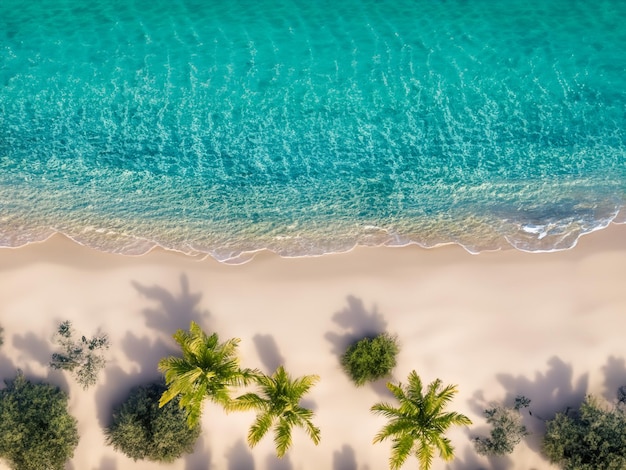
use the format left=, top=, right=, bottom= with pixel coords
left=159, top=321, right=260, bottom=428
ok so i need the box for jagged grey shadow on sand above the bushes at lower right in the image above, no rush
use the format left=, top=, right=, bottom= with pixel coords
left=497, top=356, right=589, bottom=453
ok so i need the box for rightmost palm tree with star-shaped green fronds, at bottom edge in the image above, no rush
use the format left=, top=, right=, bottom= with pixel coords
left=371, top=371, right=472, bottom=470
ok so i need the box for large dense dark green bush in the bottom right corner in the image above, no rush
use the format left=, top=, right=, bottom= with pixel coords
left=543, top=396, right=626, bottom=470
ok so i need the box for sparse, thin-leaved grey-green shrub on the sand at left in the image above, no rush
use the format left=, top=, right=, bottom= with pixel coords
left=50, top=321, right=109, bottom=389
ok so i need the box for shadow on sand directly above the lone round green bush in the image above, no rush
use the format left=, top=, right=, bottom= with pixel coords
left=324, top=295, right=387, bottom=357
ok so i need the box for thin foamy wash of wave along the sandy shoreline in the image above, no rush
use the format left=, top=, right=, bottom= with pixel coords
left=0, top=207, right=626, bottom=265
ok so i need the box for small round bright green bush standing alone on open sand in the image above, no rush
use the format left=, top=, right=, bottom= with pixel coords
left=341, top=333, right=400, bottom=386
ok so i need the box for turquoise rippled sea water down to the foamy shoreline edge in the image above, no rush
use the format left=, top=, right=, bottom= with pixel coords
left=0, top=0, right=626, bottom=261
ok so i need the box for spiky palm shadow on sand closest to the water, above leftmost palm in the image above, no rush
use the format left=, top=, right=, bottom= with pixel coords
left=132, top=274, right=209, bottom=337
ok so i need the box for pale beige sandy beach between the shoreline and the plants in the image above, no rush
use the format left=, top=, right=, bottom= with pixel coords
left=0, top=226, right=626, bottom=470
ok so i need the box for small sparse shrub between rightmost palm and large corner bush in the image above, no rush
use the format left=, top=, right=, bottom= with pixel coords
left=474, top=396, right=530, bottom=455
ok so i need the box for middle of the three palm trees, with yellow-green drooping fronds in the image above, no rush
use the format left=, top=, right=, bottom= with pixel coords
left=229, top=366, right=320, bottom=457
